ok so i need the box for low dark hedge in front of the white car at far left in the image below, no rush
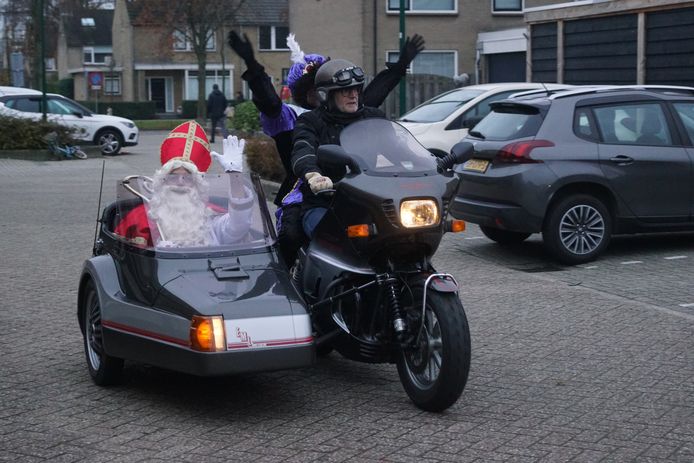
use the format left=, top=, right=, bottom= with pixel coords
left=0, top=116, right=74, bottom=150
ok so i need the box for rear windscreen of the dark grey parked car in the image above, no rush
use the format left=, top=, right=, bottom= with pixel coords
left=474, top=105, right=542, bottom=140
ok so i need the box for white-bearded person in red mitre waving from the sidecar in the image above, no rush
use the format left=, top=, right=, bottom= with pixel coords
left=114, top=121, right=254, bottom=247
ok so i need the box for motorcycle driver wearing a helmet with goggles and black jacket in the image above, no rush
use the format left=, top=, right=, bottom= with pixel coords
left=292, top=59, right=385, bottom=238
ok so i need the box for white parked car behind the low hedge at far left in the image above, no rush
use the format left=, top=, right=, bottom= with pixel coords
left=0, top=90, right=139, bottom=155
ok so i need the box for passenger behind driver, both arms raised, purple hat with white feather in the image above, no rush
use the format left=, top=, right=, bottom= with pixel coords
left=229, top=31, right=424, bottom=206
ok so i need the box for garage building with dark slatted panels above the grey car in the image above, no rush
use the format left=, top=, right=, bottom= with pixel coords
left=525, top=0, right=694, bottom=86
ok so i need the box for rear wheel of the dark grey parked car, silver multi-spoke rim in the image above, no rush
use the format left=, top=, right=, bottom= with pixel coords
left=542, top=195, right=612, bottom=265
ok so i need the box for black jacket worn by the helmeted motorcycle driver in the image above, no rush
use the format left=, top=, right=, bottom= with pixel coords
left=292, top=106, right=385, bottom=208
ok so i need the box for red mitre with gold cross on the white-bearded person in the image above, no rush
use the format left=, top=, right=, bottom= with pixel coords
left=160, top=121, right=212, bottom=173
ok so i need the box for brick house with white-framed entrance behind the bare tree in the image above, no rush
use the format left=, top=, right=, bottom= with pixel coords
left=108, top=0, right=289, bottom=113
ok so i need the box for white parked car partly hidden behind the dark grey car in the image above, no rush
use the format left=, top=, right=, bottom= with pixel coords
left=398, top=82, right=570, bottom=157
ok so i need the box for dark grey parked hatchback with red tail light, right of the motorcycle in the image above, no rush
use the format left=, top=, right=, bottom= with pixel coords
left=451, top=86, right=694, bottom=264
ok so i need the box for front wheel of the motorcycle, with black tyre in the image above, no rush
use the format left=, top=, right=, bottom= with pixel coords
left=397, top=286, right=470, bottom=412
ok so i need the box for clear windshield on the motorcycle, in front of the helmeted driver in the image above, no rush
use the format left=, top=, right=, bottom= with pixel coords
left=340, top=119, right=436, bottom=175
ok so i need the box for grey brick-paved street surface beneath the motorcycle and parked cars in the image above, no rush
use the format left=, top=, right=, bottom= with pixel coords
left=0, top=132, right=694, bottom=462
